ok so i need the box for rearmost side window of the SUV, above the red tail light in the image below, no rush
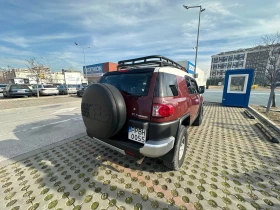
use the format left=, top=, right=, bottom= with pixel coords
left=154, top=72, right=178, bottom=97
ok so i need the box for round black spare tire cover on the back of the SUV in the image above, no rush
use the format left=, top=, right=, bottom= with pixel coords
left=81, top=83, right=126, bottom=139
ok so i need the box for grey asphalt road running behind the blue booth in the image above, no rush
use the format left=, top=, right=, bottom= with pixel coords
left=203, top=89, right=280, bottom=106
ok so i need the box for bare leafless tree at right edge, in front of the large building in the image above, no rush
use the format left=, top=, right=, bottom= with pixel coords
left=261, top=32, right=280, bottom=113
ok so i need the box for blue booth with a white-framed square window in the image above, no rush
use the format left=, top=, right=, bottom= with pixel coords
left=222, top=69, right=254, bottom=108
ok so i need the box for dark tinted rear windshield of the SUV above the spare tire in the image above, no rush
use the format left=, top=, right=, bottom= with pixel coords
left=100, top=72, right=153, bottom=96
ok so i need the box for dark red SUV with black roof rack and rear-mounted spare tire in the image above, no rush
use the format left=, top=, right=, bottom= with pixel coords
left=81, top=56, right=204, bottom=170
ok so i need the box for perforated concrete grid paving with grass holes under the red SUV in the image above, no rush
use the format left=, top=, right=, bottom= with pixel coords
left=0, top=104, right=280, bottom=210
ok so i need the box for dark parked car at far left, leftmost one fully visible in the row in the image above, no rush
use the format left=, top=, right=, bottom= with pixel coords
left=3, top=84, right=32, bottom=97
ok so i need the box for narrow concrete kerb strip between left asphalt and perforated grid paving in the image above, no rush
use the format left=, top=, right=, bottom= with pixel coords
left=0, top=132, right=87, bottom=168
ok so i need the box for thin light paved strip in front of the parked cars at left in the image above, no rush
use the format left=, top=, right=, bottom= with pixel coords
left=0, top=96, right=81, bottom=109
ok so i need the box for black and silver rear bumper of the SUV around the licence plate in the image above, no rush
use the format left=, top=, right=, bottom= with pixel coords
left=88, top=119, right=179, bottom=158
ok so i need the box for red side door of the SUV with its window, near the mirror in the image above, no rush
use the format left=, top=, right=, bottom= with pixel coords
left=185, top=76, right=200, bottom=122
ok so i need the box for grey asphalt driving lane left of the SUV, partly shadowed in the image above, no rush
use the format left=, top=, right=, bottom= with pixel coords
left=0, top=98, right=85, bottom=162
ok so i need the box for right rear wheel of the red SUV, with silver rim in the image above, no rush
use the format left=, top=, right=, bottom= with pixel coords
left=163, top=125, right=188, bottom=171
